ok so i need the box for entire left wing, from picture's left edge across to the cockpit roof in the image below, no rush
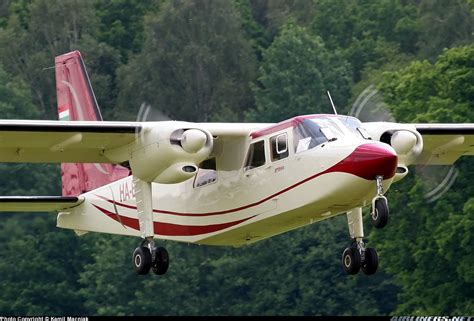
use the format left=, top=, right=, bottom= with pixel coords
left=0, top=120, right=268, bottom=163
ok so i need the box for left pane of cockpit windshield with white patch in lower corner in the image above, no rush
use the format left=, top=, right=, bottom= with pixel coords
left=293, top=119, right=328, bottom=153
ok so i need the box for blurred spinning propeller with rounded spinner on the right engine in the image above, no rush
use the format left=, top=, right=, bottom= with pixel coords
left=349, top=84, right=459, bottom=203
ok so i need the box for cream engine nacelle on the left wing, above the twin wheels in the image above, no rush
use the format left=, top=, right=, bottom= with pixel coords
left=120, top=122, right=213, bottom=184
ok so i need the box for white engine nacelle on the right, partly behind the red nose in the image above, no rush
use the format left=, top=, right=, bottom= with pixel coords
left=362, top=122, right=423, bottom=166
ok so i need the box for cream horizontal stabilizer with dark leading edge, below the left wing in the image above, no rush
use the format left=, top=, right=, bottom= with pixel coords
left=0, top=196, right=84, bottom=212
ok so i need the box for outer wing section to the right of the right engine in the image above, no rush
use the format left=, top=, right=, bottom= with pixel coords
left=413, top=124, right=474, bottom=165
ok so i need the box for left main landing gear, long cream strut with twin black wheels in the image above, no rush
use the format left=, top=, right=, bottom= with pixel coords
left=132, top=176, right=169, bottom=275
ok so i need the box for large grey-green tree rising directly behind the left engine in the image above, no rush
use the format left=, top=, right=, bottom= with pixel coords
left=120, top=0, right=255, bottom=121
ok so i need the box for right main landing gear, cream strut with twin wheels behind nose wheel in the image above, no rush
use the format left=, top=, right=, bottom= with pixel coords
left=342, top=207, right=379, bottom=275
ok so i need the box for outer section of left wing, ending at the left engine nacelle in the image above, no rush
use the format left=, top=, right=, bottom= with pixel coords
left=0, top=120, right=142, bottom=163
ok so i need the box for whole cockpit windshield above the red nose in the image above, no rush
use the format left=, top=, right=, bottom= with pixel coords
left=293, top=116, right=370, bottom=153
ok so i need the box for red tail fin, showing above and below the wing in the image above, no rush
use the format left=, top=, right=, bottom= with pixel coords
left=55, top=51, right=129, bottom=196
